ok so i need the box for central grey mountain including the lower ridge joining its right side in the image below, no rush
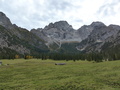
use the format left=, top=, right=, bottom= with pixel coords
left=31, top=21, right=92, bottom=51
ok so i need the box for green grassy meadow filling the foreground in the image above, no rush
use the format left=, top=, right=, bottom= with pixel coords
left=0, top=59, right=120, bottom=90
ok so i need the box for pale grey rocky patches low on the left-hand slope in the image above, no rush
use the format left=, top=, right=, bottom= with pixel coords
left=0, top=28, right=30, bottom=54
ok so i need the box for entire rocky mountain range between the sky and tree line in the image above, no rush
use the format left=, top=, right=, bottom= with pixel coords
left=0, top=12, right=120, bottom=55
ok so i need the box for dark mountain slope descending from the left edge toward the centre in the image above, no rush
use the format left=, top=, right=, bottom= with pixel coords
left=0, top=12, right=48, bottom=55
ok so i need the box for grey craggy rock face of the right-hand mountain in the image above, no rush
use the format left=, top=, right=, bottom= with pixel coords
left=77, top=23, right=120, bottom=52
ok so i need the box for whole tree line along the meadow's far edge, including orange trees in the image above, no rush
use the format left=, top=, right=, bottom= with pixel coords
left=0, top=53, right=120, bottom=62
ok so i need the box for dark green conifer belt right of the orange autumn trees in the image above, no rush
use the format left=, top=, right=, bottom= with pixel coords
left=34, top=53, right=120, bottom=62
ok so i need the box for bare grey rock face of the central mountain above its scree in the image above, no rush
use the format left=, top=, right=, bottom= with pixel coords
left=31, top=21, right=81, bottom=48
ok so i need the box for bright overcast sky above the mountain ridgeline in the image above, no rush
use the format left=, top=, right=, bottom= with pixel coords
left=0, top=0, right=120, bottom=30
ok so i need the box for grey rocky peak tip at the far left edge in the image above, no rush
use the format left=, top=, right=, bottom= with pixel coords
left=0, top=12, right=12, bottom=29
